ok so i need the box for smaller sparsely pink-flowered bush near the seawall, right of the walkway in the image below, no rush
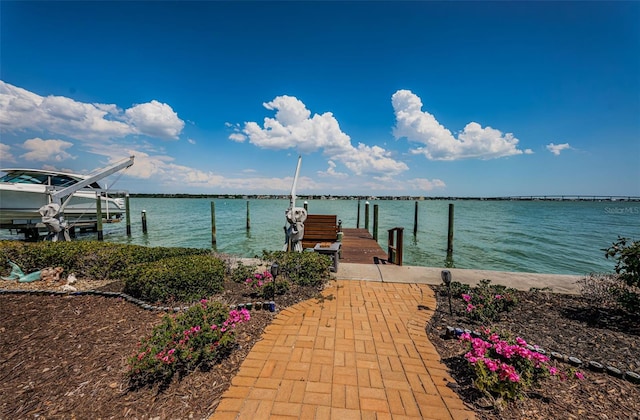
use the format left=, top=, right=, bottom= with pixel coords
left=461, top=280, right=518, bottom=322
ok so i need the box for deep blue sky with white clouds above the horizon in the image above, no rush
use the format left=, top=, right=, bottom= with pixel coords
left=0, top=1, right=640, bottom=196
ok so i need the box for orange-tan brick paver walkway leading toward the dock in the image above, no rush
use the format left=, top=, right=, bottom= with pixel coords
left=210, top=281, right=475, bottom=420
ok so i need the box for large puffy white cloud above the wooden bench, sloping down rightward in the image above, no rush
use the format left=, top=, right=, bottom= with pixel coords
left=228, top=95, right=409, bottom=176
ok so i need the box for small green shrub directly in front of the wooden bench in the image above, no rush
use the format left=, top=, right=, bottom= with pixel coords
left=262, top=251, right=332, bottom=286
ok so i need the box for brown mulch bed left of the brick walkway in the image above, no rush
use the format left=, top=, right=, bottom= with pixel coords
left=0, top=282, right=319, bottom=419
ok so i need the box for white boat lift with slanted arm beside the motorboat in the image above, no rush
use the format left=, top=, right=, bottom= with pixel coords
left=38, top=156, right=134, bottom=242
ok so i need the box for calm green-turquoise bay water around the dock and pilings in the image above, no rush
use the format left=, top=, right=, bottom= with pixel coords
left=1, top=198, right=640, bottom=274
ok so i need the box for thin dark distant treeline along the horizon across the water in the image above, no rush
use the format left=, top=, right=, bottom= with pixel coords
left=130, top=194, right=640, bottom=201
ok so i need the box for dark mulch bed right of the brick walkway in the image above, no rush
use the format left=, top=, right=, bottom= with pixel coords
left=427, top=287, right=640, bottom=419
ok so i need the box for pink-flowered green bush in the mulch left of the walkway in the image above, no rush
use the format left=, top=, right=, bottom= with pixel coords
left=128, top=299, right=251, bottom=388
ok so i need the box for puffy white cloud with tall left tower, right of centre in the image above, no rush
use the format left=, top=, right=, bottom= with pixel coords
left=391, top=90, right=524, bottom=160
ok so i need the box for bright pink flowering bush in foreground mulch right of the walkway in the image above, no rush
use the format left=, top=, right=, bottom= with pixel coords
left=460, top=329, right=584, bottom=400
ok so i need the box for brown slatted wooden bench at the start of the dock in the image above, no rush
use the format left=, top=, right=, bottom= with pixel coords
left=302, top=214, right=341, bottom=271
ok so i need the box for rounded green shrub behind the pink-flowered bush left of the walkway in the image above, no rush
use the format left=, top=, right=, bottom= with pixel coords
left=122, top=255, right=225, bottom=303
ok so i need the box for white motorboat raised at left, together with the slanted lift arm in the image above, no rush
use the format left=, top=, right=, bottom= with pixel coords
left=0, top=157, right=133, bottom=238
